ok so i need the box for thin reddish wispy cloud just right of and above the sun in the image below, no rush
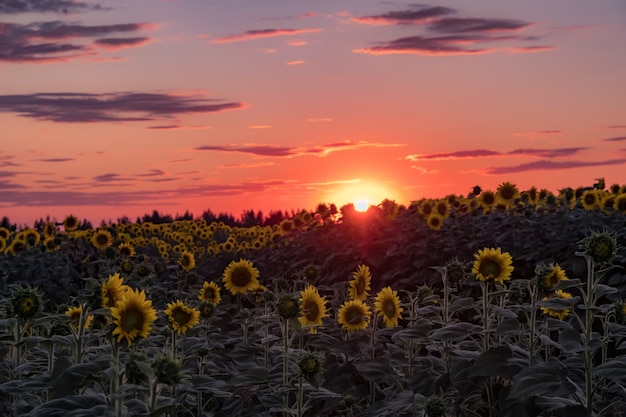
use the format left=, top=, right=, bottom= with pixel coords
left=405, top=147, right=589, bottom=161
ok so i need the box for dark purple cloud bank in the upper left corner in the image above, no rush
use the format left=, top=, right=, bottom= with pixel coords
left=0, top=21, right=154, bottom=63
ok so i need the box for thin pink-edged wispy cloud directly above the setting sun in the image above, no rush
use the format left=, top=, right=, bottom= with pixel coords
left=194, top=141, right=405, bottom=158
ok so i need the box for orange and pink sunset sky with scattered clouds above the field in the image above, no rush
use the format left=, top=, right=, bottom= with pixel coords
left=0, top=0, right=626, bottom=224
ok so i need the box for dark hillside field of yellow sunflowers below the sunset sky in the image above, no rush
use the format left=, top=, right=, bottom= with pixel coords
left=0, top=179, right=626, bottom=417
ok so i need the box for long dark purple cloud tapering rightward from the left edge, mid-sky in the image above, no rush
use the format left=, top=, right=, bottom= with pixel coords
left=0, top=92, right=244, bottom=123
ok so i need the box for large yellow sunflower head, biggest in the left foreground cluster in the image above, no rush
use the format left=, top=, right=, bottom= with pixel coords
left=111, top=290, right=157, bottom=345
